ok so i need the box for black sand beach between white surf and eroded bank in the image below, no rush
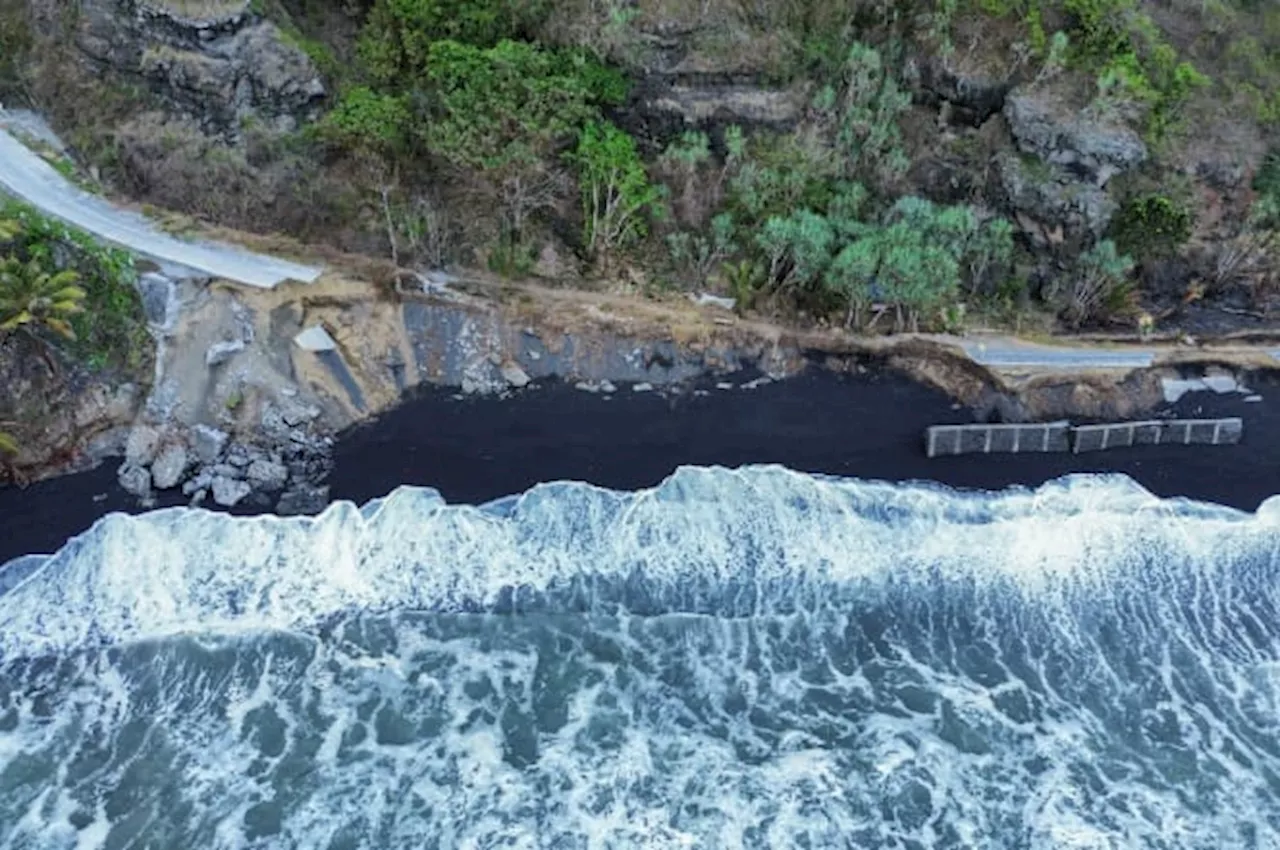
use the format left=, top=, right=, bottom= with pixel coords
left=0, top=371, right=1280, bottom=563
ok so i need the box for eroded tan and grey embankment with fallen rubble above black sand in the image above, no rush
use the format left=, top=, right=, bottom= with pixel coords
left=5, top=273, right=1267, bottom=512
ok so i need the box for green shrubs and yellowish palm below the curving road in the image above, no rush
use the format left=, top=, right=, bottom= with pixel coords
left=0, top=201, right=151, bottom=369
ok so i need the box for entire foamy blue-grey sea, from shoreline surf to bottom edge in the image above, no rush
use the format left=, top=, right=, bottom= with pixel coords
left=0, top=467, right=1280, bottom=850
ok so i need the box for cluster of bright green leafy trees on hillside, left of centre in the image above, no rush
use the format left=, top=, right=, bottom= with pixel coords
left=320, top=0, right=624, bottom=258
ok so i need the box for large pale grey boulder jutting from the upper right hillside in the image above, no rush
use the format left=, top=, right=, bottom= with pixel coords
left=1004, top=92, right=1147, bottom=187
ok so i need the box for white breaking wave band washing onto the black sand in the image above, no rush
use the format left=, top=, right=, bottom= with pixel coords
left=0, top=466, right=1280, bottom=659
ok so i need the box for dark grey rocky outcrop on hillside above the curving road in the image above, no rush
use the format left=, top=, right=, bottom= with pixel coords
left=74, top=0, right=325, bottom=138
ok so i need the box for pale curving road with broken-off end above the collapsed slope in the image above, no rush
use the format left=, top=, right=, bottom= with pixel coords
left=0, top=129, right=323, bottom=289
